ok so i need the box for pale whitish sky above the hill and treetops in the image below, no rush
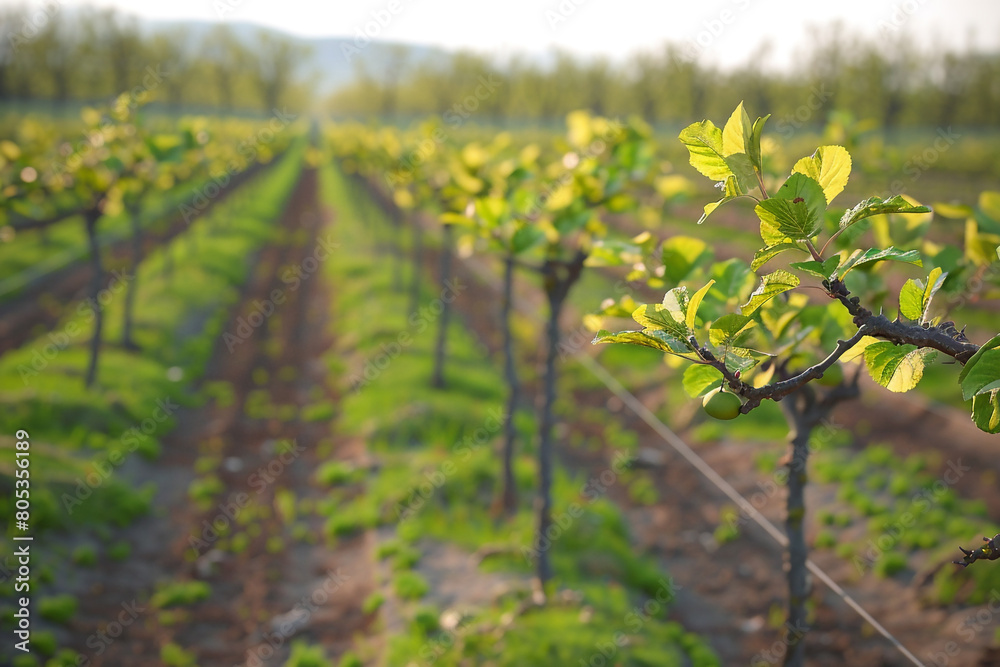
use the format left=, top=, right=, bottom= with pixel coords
left=7, top=0, right=1000, bottom=67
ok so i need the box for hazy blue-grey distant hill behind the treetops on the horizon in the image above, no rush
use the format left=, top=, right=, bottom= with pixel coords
left=141, top=21, right=448, bottom=96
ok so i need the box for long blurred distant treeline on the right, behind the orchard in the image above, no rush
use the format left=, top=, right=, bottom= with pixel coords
left=327, top=26, right=1000, bottom=132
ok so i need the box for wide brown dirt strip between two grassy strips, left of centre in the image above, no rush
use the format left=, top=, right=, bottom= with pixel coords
left=63, top=169, right=372, bottom=667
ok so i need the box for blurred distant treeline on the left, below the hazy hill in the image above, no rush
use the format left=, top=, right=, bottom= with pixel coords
left=0, top=4, right=310, bottom=112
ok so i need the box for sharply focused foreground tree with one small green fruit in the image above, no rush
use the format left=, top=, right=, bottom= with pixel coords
left=595, top=103, right=1000, bottom=665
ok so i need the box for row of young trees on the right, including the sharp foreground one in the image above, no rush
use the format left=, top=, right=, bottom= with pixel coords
left=330, top=102, right=1000, bottom=667
